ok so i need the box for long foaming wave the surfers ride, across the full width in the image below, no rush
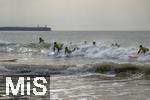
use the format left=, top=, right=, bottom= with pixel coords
left=0, top=43, right=150, bottom=61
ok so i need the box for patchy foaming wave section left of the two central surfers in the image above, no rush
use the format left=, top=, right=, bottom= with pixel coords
left=0, top=43, right=51, bottom=54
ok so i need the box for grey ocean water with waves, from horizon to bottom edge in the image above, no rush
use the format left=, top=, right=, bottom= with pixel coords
left=0, top=31, right=150, bottom=100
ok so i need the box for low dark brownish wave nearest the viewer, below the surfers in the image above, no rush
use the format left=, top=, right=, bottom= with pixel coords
left=0, top=62, right=150, bottom=78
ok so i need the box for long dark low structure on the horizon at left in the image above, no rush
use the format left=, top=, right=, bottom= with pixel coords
left=0, top=27, right=51, bottom=31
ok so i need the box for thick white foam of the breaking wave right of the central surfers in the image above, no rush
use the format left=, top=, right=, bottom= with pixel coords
left=71, top=44, right=150, bottom=61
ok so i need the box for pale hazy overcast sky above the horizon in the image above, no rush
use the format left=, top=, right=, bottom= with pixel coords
left=0, top=0, right=150, bottom=31
